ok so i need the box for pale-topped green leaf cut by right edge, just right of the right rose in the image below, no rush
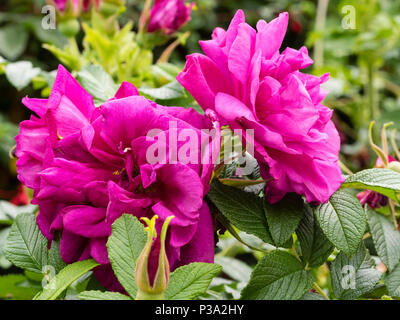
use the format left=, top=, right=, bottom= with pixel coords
left=341, top=168, right=400, bottom=202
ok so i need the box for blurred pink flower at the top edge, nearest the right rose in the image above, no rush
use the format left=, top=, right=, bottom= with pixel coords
left=148, top=0, right=194, bottom=34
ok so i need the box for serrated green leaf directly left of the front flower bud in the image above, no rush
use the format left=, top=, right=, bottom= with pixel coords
left=107, top=214, right=147, bottom=297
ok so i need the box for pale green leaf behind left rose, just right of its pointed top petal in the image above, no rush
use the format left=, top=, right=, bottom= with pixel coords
left=77, top=65, right=118, bottom=105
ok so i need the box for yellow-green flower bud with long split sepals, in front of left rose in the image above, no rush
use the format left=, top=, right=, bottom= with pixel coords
left=135, top=215, right=174, bottom=300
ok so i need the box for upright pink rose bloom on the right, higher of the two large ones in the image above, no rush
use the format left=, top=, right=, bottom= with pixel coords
left=177, top=10, right=343, bottom=203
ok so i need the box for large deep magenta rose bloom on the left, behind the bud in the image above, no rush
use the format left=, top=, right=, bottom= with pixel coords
left=16, top=66, right=219, bottom=290
